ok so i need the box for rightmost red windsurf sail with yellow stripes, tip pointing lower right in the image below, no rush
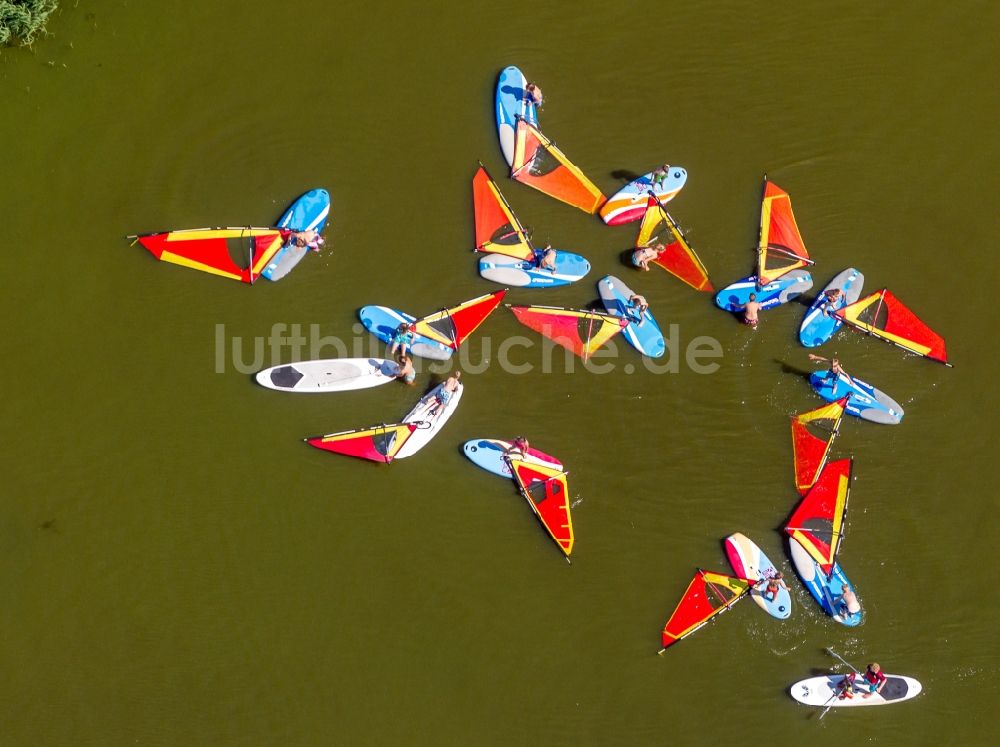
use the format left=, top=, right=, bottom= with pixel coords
left=833, top=288, right=951, bottom=366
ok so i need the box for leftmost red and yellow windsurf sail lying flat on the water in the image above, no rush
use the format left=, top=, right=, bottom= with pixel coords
left=135, top=227, right=288, bottom=283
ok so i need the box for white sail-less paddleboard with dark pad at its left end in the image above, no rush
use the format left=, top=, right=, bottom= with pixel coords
left=256, top=358, right=399, bottom=393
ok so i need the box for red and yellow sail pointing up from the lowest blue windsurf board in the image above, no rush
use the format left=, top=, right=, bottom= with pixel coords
left=785, top=459, right=853, bottom=576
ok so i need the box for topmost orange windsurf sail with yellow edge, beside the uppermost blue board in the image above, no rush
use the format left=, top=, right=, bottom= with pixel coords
left=510, top=118, right=607, bottom=214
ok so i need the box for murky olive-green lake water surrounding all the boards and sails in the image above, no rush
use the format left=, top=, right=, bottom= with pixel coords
left=0, top=0, right=1000, bottom=745
